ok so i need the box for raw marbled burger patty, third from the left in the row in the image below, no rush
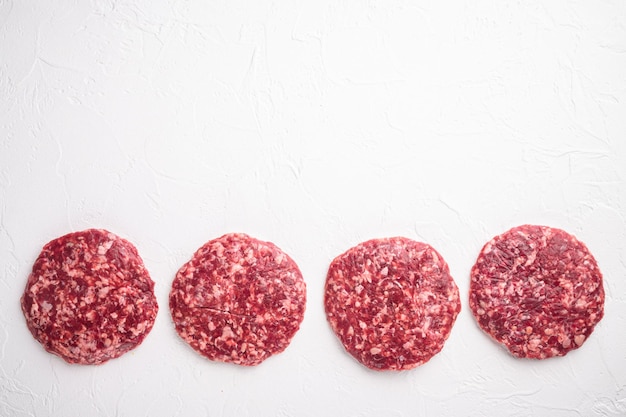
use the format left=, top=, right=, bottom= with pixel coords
left=324, top=237, right=461, bottom=370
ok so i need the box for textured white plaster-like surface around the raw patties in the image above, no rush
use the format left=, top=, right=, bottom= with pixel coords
left=0, top=0, right=626, bottom=417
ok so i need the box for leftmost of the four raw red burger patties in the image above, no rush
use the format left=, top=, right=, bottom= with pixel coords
left=21, top=229, right=158, bottom=364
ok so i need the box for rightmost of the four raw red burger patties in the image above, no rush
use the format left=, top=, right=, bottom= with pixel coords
left=469, top=225, right=604, bottom=359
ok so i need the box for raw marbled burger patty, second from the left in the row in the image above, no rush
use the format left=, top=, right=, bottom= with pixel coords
left=170, top=234, right=306, bottom=366
